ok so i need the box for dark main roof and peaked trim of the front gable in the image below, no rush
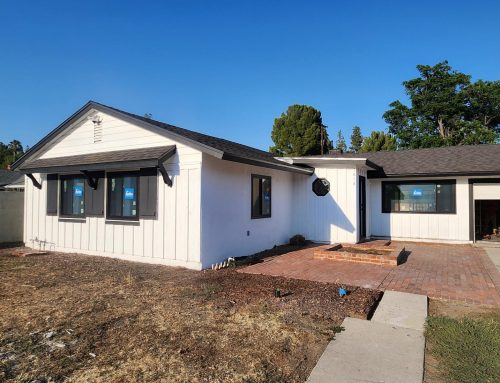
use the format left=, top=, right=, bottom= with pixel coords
left=12, top=101, right=314, bottom=175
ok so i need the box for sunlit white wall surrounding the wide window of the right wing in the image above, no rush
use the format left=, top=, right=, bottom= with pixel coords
left=368, top=177, right=472, bottom=243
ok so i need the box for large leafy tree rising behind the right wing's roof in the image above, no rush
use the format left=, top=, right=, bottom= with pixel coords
left=383, top=61, right=500, bottom=148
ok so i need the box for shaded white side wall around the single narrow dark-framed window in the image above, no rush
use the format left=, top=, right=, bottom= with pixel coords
left=201, top=154, right=296, bottom=267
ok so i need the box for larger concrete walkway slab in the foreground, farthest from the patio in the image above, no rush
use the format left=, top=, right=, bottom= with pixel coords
left=307, top=318, right=425, bottom=383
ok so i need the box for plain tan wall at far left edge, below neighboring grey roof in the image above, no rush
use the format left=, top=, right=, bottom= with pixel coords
left=0, top=191, right=24, bottom=243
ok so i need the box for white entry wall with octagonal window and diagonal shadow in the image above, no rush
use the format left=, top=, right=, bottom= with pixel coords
left=293, top=165, right=358, bottom=243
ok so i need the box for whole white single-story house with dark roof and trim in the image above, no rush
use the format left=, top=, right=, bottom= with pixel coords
left=9, top=102, right=500, bottom=269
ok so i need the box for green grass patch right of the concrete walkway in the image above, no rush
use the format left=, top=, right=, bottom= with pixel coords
left=425, top=316, right=500, bottom=383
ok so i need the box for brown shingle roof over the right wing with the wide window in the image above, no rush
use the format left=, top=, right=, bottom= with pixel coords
left=292, top=144, right=500, bottom=178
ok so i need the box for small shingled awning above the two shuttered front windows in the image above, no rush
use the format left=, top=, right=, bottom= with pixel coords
left=18, top=145, right=176, bottom=173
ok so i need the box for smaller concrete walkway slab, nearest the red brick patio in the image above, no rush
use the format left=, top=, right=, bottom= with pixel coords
left=372, top=291, right=427, bottom=331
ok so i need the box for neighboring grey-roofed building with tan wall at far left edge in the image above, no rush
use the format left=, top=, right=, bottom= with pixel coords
left=0, top=169, right=24, bottom=243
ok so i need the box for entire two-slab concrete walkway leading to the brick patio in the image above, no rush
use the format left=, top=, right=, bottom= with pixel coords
left=307, top=291, right=427, bottom=383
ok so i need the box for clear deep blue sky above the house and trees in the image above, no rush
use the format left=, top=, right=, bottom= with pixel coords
left=0, top=0, right=500, bottom=150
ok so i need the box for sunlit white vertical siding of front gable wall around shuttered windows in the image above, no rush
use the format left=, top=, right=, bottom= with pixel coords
left=24, top=109, right=202, bottom=269
